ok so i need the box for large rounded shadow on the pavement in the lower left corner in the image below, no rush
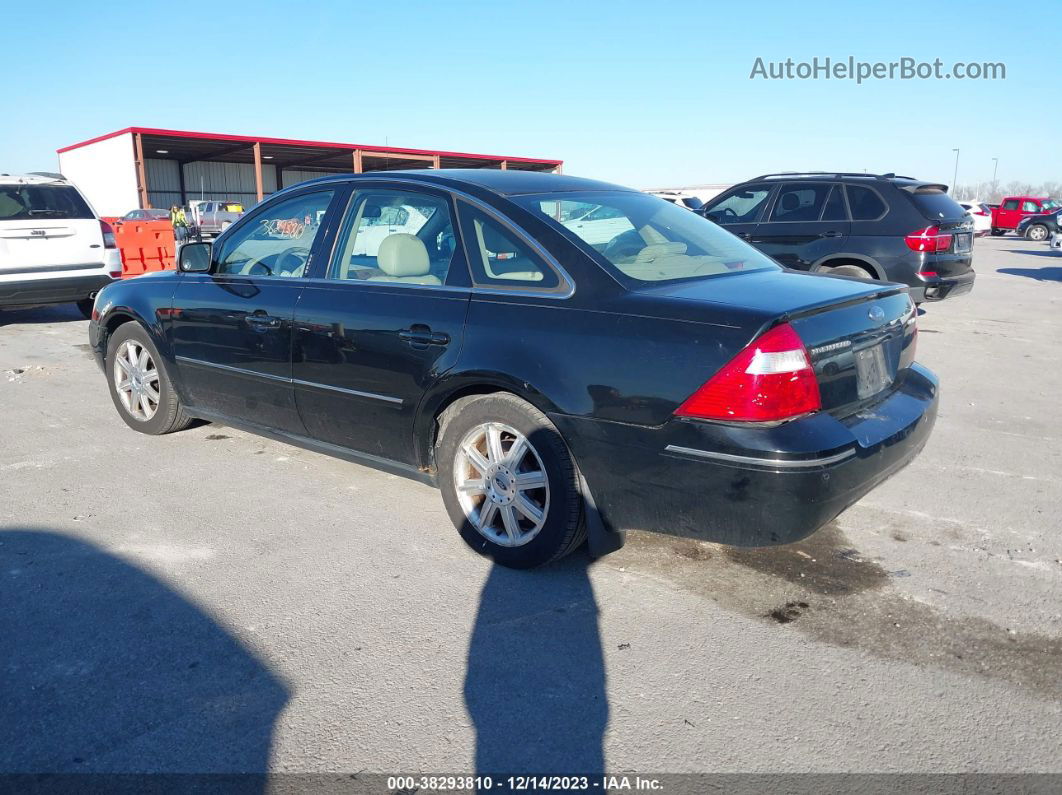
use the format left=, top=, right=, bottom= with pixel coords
left=0, top=530, right=288, bottom=772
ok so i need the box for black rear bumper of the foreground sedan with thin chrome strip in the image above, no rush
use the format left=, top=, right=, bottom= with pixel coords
left=553, top=365, right=938, bottom=547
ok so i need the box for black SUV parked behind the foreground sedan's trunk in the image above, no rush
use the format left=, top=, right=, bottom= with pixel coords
left=700, top=172, right=974, bottom=303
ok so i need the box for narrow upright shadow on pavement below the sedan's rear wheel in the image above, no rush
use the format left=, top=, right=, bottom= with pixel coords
left=464, top=552, right=609, bottom=790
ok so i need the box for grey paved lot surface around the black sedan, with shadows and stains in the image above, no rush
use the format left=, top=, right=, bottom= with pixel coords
left=0, top=238, right=1062, bottom=773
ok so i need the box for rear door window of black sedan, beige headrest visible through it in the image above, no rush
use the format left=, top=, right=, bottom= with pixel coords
left=328, top=189, right=455, bottom=287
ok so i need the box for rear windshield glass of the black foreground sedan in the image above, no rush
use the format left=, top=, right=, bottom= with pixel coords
left=514, top=191, right=778, bottom=282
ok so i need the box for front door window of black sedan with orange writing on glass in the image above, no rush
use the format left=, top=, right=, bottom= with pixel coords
left=215, top=190, right=333, bottom=278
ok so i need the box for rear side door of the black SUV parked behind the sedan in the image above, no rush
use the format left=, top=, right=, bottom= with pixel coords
left=752, top=183, right=852, bottom=271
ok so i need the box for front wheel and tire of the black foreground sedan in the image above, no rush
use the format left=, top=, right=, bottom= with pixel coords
left=106, top=322, right=192, bottom=436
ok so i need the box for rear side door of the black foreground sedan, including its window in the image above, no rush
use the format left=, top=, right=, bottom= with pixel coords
left=292, top=184, right=470, bottom=464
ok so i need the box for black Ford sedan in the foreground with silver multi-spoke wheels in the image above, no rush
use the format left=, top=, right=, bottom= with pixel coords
left=89, top=170, right=938, bottom=568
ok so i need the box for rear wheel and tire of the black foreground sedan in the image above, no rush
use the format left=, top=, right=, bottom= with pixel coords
left=435, top=393, right=586, bottom=569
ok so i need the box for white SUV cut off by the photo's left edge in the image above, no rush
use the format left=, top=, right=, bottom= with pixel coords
left=0, top=174, right=122, bottom=317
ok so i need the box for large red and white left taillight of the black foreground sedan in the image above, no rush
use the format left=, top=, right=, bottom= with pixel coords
left=675, top=324, right=822, bottom=422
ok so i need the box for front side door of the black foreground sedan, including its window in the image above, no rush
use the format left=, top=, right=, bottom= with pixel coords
left=170, top=188, right=337, bottom=433
